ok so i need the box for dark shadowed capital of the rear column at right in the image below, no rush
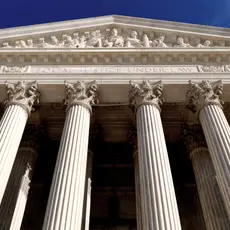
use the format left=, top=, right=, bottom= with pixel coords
left=181, top=124, right=207, bottom=157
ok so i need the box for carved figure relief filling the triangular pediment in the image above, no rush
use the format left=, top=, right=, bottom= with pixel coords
left=1, top=28, right=226, bottom=48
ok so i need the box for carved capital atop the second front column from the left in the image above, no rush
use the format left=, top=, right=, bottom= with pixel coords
left=64, top=81, right=98, bottom=113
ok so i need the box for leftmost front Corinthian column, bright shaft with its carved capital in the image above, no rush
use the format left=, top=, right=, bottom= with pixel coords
left=0, top=81, right=39, bottom=203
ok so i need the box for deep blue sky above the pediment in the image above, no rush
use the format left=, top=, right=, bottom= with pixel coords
left=0, top=0, right=230, bottom=29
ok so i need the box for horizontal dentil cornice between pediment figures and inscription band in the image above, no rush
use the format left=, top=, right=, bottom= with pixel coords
left=0, top=47, right=230, bottom=65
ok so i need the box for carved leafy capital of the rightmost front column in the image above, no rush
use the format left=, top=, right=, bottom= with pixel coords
left=186, top=80, right=224, bottom=113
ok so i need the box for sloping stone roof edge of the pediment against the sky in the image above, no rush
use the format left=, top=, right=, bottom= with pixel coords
left=0, top=15, right=230, bottom=39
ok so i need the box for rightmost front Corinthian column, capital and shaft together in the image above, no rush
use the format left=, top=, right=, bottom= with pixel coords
left=186, top=81, right=230, bottom=217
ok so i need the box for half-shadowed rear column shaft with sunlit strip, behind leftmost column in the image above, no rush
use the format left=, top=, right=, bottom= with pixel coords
left=0, top=147, right=37, bottom=230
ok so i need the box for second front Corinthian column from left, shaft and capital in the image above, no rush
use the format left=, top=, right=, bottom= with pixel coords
left=43, top=82, right=97, bottom=230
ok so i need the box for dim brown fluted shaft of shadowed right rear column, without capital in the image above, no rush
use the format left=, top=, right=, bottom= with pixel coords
left=190, top=147, right=230, bottom=230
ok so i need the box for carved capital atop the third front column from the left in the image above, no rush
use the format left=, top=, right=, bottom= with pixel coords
left=129, top=81, right=164, bottom=110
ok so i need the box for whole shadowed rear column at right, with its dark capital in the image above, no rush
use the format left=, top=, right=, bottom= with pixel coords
left=182, top=125, right=230, bottom=230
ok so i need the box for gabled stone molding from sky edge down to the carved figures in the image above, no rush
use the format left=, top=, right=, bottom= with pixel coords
left=0, top=15, right=230, bottom=42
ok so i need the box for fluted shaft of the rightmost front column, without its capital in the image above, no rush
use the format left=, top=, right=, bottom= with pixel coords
left=199, top=105, right=230, bottom=217
